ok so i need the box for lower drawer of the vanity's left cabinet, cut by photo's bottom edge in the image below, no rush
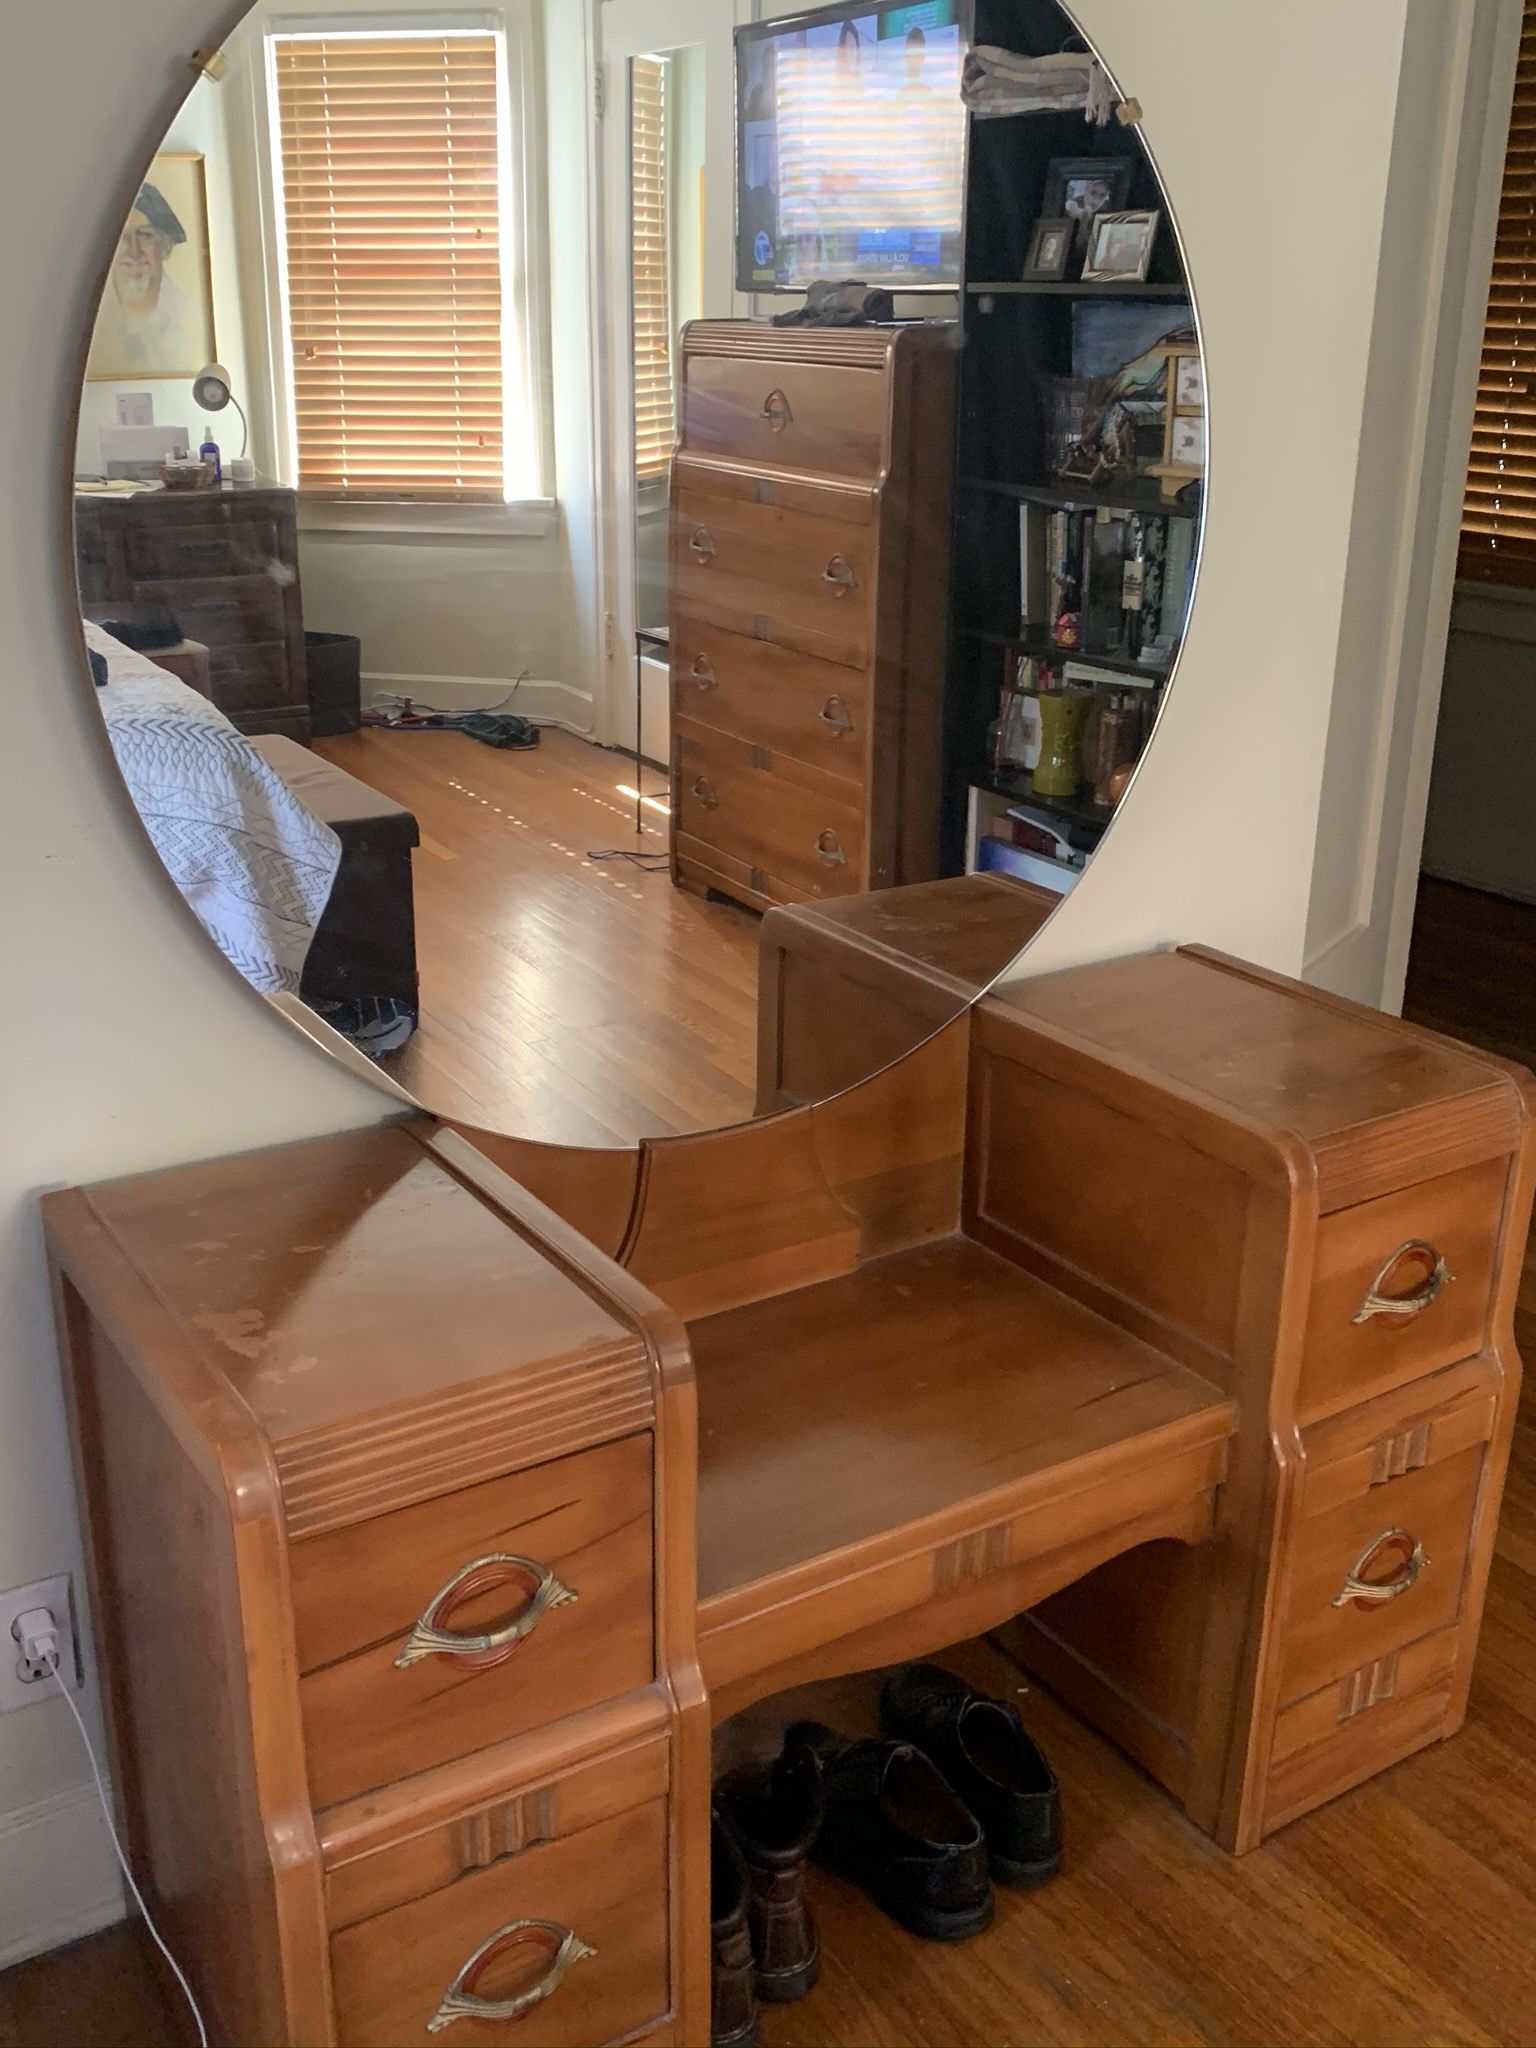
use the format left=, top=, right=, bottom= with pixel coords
left=330, top=1800, right=670, bottom=2048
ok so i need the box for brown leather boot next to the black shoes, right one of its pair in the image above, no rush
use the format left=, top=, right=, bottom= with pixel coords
left=721, top=1743, right=821, bottom=2005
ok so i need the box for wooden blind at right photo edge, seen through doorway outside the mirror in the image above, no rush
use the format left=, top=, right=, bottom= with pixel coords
left=1460, top=0, right=1536, bottom=586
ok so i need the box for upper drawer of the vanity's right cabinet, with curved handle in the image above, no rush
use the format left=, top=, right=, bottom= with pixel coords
left=1296, top=1159, right=1509, bottom=1421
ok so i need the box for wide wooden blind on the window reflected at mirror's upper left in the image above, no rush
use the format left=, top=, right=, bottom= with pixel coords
left=274, top=35, right=504, bottom=500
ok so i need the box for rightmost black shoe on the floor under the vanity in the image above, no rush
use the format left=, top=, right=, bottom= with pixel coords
left=881, top=1665, right=1061, bottom=1886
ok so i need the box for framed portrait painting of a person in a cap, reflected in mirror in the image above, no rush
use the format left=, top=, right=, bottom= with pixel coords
left=86, top=150, right=219, bottom=383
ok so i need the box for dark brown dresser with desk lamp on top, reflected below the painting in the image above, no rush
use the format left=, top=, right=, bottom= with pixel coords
left=76, top=483, right=309, bottom=739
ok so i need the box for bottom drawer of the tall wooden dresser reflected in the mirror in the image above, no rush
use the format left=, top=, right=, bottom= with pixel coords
left=672, top=719, right=864, bottom=897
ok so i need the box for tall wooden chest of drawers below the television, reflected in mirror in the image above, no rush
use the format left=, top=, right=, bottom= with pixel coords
left=672, top=319, right=956, bottom=909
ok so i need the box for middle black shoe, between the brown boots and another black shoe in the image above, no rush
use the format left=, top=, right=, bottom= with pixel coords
left=784, top=1720, right=991, bottom=1942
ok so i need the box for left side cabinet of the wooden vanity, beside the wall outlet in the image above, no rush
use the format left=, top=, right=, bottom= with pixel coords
left=45, top=1124, right=709, bottom=2048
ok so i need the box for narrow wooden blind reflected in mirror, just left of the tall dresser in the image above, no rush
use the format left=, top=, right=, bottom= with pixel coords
left=629, top=57, right=676, bottom=479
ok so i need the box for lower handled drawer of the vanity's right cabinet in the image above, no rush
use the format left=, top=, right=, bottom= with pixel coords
left=1276, top=1360, right=1497, bottom=1706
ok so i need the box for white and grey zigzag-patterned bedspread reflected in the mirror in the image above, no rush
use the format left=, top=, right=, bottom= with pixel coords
left=86, top=623, right=342, bottom=995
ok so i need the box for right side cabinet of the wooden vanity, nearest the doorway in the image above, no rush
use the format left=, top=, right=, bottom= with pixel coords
left=967, top=948, right=1536, bottom=1851
